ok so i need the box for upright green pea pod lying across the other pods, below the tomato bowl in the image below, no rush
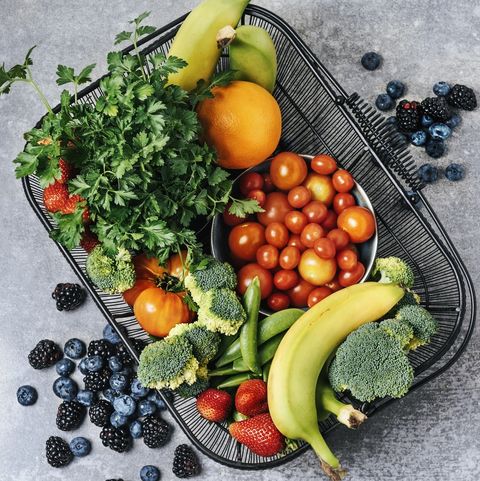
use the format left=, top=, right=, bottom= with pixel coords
left=239, top=277, right=262, bottom=374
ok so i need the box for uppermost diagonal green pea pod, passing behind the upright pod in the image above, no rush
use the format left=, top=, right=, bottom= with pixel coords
left=215, top=309, right=305, bottom=367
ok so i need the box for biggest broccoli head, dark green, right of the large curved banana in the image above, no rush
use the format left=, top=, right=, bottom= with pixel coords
left=329, top=323, right=413, bottom=402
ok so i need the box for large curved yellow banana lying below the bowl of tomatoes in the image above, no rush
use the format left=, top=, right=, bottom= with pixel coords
left=268, top=282, right=404, bottom=480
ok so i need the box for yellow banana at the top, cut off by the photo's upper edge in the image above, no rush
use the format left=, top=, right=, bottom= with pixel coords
left=168, top=0, right=249, bottom=91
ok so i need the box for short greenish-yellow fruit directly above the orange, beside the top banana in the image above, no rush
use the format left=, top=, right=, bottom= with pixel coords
left=230, top=25, right=277, bottom=92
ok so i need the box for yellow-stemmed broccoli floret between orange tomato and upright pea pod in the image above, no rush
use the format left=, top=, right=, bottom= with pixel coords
left=198, top=289, right=247, bottom=336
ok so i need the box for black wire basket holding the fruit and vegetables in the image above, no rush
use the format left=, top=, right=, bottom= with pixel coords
left=23, top=5, right=475, bottom=469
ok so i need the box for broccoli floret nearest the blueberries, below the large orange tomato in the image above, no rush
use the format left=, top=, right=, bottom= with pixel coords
left=137, top=336, right=199, bottom=389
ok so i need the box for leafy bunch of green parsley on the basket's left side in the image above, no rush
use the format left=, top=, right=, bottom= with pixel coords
left=0, top=13, right=261, bottom=262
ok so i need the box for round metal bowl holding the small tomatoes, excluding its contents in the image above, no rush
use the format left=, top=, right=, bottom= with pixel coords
left=211, top=154, right=378, bottom=315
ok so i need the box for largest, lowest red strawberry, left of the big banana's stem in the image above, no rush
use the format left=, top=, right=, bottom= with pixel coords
left=228, top=413, right=285, bottom=457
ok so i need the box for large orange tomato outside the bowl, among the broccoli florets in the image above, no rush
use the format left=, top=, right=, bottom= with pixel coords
left=133, top=287, right=190, bottom=337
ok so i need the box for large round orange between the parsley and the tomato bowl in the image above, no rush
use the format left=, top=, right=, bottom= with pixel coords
left=197, top=80, right=282, bottom=169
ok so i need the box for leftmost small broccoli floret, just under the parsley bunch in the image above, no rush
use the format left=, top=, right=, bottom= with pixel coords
left=85, top=245, right=135, bottom=294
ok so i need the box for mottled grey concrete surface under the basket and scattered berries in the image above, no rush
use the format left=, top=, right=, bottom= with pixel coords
left=0, top=0, right=480, bottom=481
